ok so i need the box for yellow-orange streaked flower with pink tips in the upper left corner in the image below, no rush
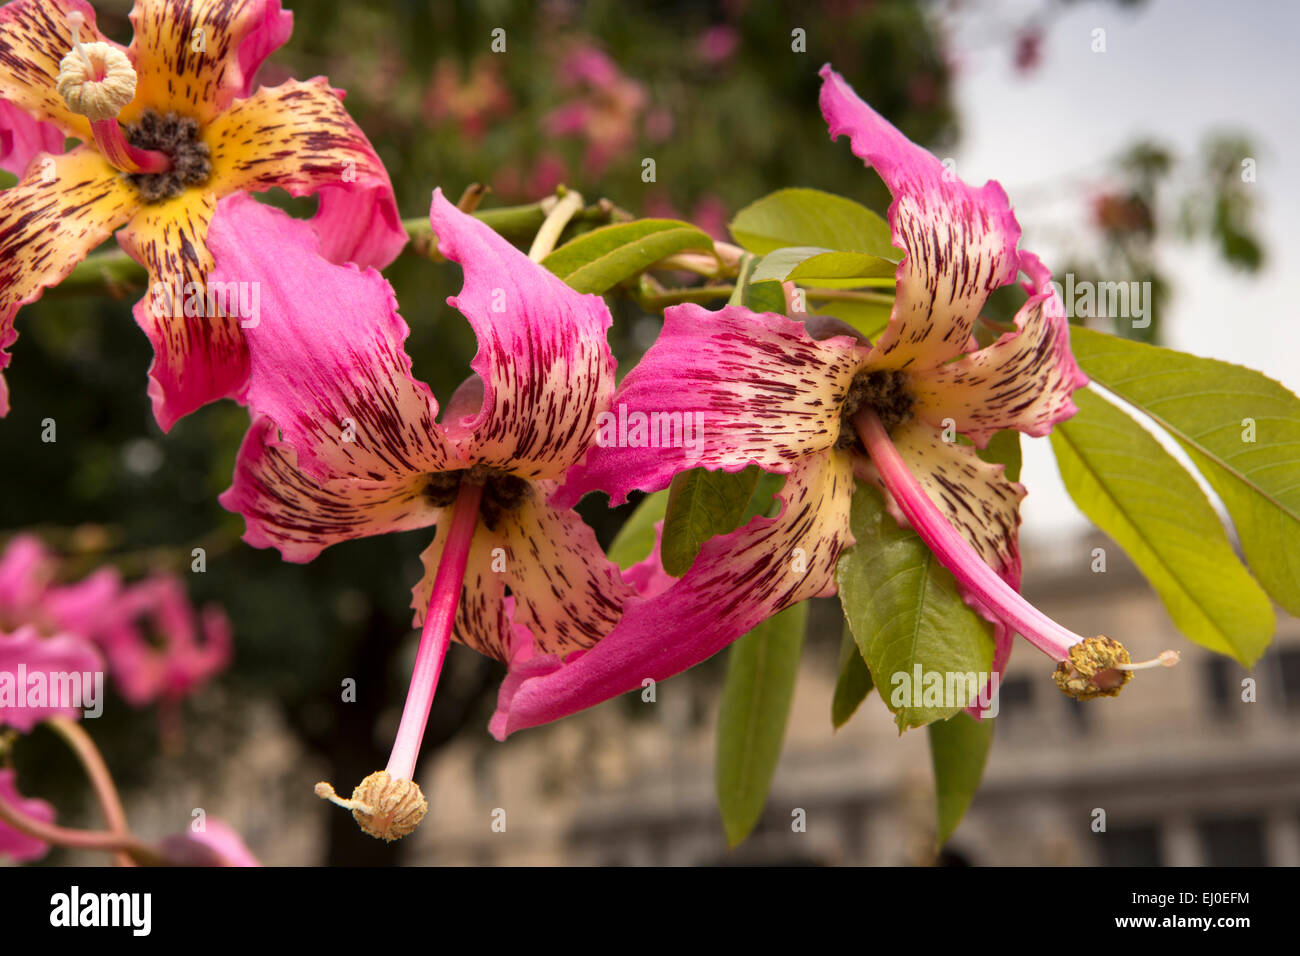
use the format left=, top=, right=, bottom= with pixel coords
left=0, top=0, right=406, bottom=429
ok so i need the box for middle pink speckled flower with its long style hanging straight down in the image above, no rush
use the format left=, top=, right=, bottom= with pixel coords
left=212, top=190, right=632, bottom=840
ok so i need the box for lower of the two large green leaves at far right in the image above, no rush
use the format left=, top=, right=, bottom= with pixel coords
left=1052, top=389, right=1274, bottom=667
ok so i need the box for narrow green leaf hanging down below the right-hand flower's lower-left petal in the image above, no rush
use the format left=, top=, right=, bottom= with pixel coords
left=715, top=601, right=809, bottom=847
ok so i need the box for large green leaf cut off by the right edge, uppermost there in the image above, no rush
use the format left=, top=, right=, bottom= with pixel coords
left=1070, top=329, right=1300, bottom=614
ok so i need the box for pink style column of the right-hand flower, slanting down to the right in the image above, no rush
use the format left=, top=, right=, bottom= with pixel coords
left=853, top=407, right=1084, bottom=661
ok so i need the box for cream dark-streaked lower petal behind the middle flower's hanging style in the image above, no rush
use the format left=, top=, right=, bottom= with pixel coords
left=412, top=481, right=633, bottom=661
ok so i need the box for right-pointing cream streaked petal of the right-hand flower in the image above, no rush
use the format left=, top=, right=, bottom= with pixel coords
left=913, top=252, right=1088, bottom=447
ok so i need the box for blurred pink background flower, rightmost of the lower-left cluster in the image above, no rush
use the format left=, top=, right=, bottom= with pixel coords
left=94, top=575, right=230, bottom=708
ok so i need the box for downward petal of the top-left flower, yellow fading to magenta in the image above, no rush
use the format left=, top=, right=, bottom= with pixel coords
left=117, top=190, right=248, bottom=432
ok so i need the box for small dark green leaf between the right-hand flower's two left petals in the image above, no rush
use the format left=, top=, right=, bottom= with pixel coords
left=659, top=464, right=761, bottom=578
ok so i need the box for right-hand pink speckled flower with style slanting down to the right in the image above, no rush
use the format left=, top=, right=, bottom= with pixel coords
left=493, top=66, right=1177, bottom=736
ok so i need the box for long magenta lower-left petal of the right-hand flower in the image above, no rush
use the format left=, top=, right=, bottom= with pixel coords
left=491, top=450, right=853, bottom=739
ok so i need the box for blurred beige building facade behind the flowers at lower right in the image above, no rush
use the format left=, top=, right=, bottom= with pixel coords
left=411, top=538, right=1300, bottom=866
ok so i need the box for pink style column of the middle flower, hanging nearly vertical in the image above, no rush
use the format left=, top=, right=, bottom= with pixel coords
left=387, top=480, right=484, bottom=780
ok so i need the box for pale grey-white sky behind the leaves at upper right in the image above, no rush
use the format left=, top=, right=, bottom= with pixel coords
left=945, top=0, right=1300, bottom=544
